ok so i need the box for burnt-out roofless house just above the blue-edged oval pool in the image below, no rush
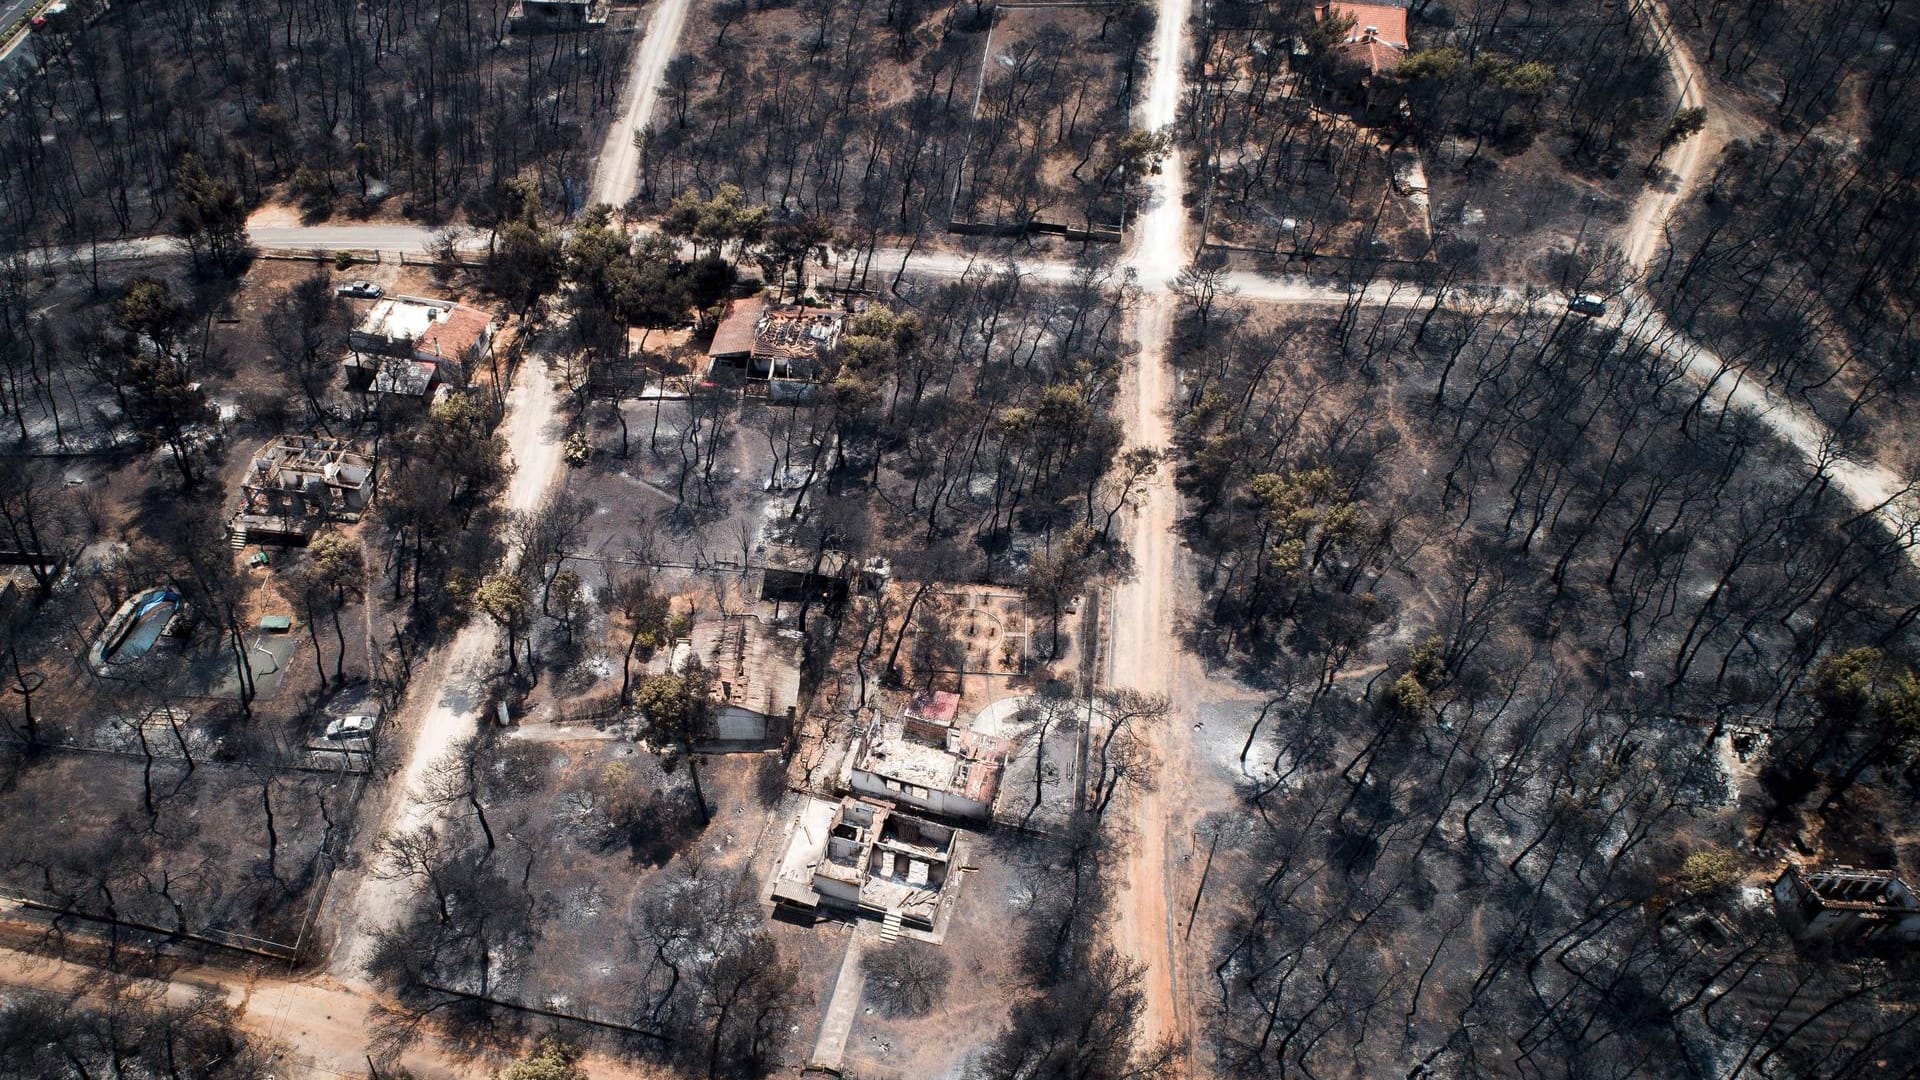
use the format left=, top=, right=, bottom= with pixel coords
left=228, top=434, right=372, bottom=548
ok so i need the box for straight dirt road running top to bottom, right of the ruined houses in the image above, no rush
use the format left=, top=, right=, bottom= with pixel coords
left=1108, top=0, right=1188, bottom=1074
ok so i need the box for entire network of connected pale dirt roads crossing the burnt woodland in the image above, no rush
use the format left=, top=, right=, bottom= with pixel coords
left=0, top=0, right=1910, bottom=1076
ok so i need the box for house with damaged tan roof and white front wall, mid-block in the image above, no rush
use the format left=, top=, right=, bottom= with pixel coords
left=674, top=615, right=801, bottom=744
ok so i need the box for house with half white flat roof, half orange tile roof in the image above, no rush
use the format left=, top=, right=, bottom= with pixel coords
left=346, top=296, right=493, bottom=398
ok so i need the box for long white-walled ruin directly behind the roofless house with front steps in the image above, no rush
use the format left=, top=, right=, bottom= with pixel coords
left=841, top=715, right=1014, bottom=821
